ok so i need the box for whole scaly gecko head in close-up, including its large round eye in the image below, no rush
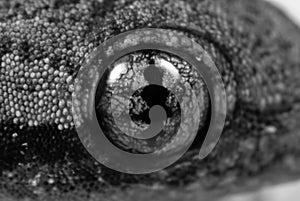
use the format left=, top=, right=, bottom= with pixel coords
left=0, top=0, right=300, bottom=200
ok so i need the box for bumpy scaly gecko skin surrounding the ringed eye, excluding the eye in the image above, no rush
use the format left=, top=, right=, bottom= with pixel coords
left=0, top=0, right=300, bottom=200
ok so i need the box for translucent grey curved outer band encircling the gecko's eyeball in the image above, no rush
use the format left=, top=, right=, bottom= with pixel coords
left=72, top=28, right=227, bottom=174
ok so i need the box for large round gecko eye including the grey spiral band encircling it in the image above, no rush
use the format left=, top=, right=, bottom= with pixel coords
left=73, top=29, right=226, bottom=174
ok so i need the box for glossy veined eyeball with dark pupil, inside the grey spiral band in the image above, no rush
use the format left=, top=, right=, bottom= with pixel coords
left=95, top=50, right=209, bottom=153
